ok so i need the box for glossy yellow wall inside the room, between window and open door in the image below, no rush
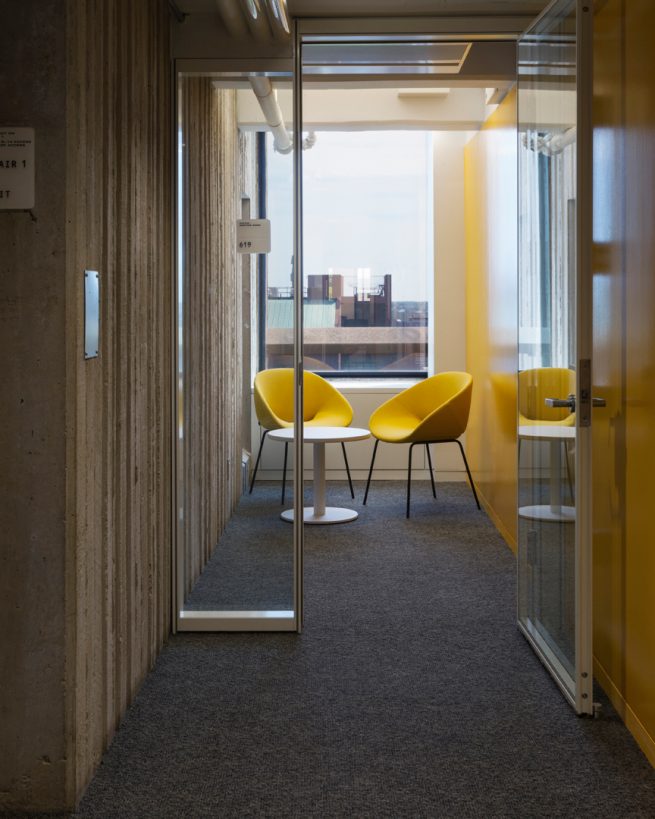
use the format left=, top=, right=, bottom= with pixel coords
left=464, top=91, right=517, bottom=551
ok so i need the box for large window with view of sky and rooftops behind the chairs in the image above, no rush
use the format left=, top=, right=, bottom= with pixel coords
left=260, top=131, right=433, bottom=375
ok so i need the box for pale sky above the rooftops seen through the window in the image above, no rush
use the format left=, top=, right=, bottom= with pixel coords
left=267, top=131, right=433, bottom=301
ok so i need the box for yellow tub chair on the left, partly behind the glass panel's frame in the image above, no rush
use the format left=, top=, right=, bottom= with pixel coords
left=250, top=367, right=355, bottom=503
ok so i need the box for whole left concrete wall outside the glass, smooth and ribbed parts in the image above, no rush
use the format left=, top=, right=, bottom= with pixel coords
left=0, top=0, right=172, bottom=811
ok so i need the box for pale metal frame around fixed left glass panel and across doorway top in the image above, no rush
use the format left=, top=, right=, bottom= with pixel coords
left=171, top=9, right=548, bottom=633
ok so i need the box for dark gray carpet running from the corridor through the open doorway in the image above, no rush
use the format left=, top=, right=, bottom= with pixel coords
left=76, top=482, right=655, bottom=819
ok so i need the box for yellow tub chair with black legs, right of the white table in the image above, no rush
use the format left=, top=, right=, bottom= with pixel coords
left=364, top=372, right=480, bottom=517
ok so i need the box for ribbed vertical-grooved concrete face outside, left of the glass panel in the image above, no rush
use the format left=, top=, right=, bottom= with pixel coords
left=66, top=0, right=172, bottom=795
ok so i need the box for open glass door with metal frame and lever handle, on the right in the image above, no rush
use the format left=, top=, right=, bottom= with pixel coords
left=518, top=0, right=593, bottom=714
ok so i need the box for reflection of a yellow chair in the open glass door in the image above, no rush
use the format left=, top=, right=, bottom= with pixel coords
left=518, top=367, right=575, bottom=499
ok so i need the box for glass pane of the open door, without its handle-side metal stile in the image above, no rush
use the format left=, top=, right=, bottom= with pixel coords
left=518, top=2, right=576, bottom=696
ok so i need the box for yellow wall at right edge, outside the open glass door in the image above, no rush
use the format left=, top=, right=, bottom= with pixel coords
left=593, top=0, right=655, bottom=765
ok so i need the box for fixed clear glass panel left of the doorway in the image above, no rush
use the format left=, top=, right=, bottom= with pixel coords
left=175, top=71, right=302, bottom=631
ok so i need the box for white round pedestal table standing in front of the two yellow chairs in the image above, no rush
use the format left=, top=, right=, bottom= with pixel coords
left=268, top=427, right=371, bottom=524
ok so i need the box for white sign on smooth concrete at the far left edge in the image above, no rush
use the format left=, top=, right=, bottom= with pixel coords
left=0, top=126, right=34, bottom=210
